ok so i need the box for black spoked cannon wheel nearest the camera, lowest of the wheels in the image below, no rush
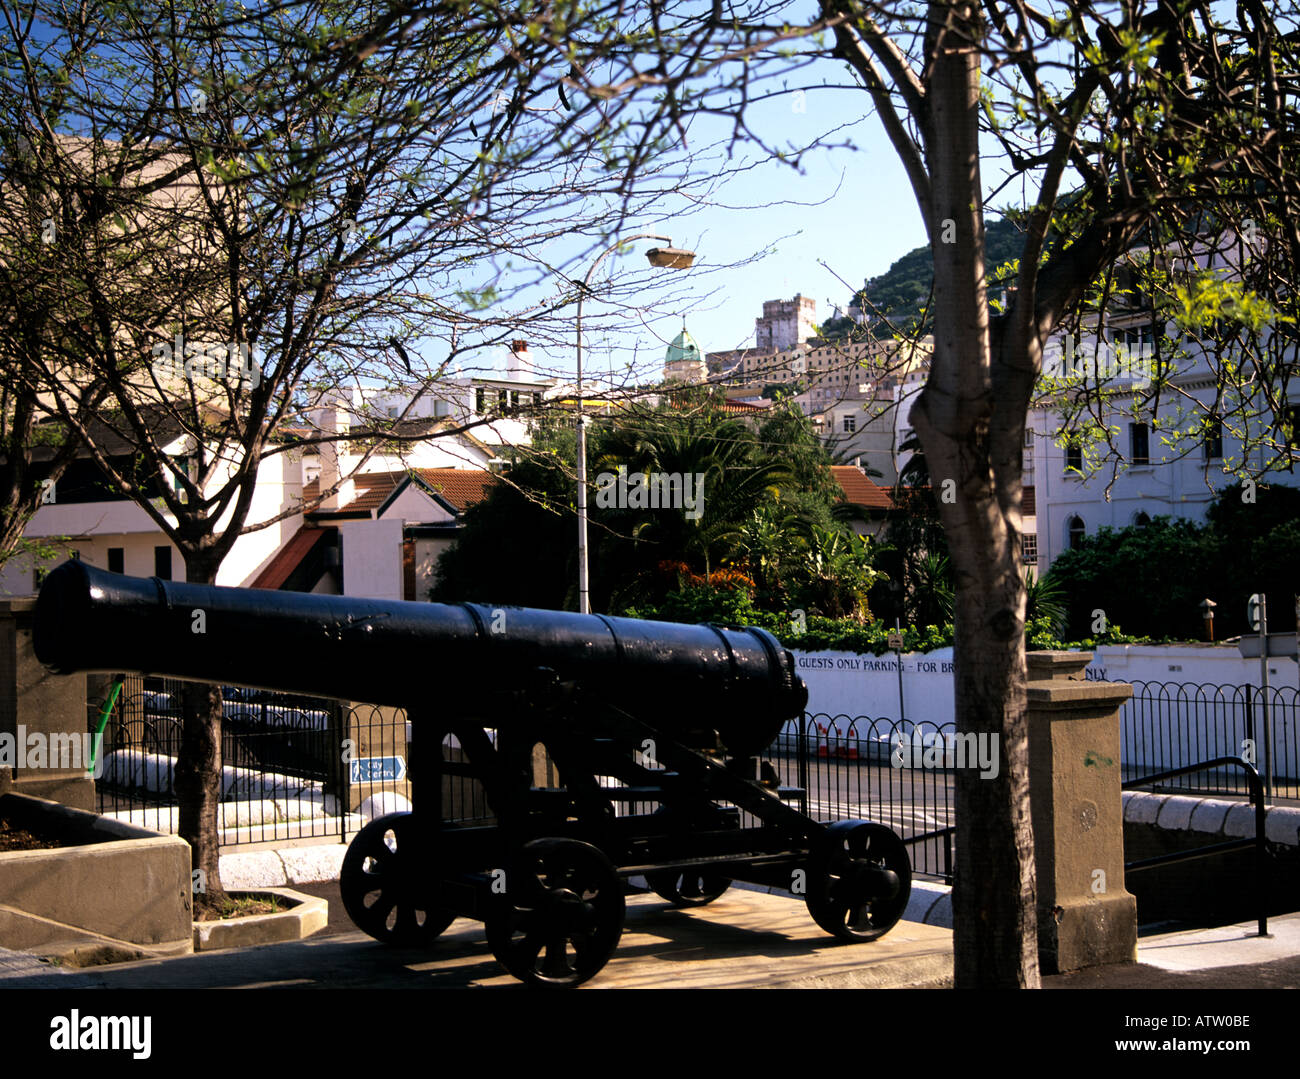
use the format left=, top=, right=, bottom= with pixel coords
left=486, top=837, right=627, bottom=988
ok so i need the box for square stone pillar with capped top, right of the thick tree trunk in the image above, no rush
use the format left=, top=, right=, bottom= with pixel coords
left=1026, top=651, right=1138, bottom=974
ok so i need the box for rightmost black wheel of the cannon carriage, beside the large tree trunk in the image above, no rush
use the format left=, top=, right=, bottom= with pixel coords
left=807, top=820, right=911, bottom=941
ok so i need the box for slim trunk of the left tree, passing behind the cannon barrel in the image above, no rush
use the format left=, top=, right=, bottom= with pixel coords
left=176, top=551, right=225, bottom=913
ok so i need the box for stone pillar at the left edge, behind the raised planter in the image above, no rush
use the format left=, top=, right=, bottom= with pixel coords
left=0, top=595, right=95, bottom=811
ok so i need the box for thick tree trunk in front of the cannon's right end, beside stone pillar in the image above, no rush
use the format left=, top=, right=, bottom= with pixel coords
left=911, top=0, right=1039, bottom=988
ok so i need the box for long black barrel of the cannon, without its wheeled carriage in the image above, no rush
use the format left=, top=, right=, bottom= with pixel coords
left=34, top=560, right=807, bottom=755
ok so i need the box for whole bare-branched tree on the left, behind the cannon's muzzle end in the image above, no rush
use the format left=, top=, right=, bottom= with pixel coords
left=0, top=0, right=728, bottom=902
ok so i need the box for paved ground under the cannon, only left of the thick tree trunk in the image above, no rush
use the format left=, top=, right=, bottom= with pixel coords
left=0, top=884, right=952, bottom=989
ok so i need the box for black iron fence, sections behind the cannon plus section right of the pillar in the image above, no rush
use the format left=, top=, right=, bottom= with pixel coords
left=81, top=677, right=1300, bottom=881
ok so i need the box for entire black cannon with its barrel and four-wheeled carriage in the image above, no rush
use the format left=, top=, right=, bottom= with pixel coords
left=34, top=562, right=911, bottom=987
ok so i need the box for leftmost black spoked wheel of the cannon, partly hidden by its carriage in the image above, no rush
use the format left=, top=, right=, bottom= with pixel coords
left=338, top=813, right=456, bottom=948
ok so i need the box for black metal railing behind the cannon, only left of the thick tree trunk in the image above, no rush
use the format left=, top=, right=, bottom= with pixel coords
left=90, top=677, right=954, bottom=868
